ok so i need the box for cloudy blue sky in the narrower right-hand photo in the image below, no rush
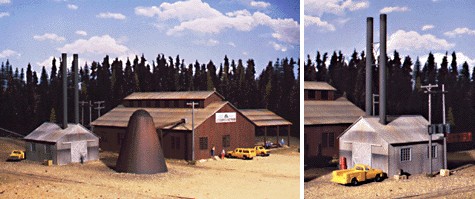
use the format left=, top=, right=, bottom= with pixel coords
left=303, top=0, right=475, bottom=67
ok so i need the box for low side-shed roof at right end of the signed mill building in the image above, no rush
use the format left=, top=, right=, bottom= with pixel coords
left=239, top=109, right=292, bottom=127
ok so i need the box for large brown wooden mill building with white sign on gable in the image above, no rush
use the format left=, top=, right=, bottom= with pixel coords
left=91, top=91, right=291, bottom=160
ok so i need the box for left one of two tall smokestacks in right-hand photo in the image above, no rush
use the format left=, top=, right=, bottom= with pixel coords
left=365, top=17, right=373, bottom=115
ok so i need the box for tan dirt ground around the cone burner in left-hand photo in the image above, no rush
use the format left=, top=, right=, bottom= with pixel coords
left=0, top=138, right=300, bottom=198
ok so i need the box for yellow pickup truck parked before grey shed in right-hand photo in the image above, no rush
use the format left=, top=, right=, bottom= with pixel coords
left=331, top=164, right=384, bottom=185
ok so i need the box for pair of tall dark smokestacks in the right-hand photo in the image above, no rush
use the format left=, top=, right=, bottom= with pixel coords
left=365, top=14, right=387, bottom=125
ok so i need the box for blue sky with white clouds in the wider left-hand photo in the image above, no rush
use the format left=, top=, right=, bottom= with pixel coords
left=0, top=0, right=300, bottom=73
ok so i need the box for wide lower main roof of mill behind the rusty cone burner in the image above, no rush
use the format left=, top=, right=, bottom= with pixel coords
left=91, top=101, right=229, bottom=130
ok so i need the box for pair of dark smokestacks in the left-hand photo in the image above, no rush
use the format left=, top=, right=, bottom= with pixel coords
left=61, top=53, right=79, bottom=129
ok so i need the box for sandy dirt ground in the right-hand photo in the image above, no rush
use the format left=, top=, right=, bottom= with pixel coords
left=304, top=150, right=475, bottom=198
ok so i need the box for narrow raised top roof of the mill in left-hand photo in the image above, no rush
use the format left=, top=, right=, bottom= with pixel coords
left=124, top=91, right=224, bottom=100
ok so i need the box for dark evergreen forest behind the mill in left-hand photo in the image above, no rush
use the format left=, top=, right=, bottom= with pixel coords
left=0, top=54, right=299, bottom=135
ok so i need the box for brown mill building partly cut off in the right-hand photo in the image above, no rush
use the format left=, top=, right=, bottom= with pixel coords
left=304, top=81, right=365, bottom=166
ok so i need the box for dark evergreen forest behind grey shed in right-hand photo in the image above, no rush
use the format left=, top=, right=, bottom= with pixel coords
left=304, top=50, right=475, bottom=132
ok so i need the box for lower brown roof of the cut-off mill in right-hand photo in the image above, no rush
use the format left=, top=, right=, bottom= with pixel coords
left=304, top=97, right=365, bottom=125
